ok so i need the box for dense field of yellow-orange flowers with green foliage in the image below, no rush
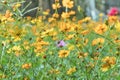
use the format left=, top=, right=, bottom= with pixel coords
left=0, top=0, right=120, bottom=80
